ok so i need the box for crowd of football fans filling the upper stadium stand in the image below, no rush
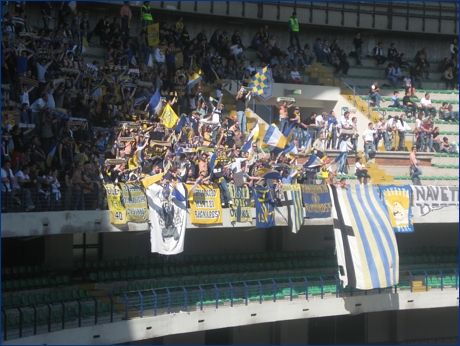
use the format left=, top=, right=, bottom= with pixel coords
left=1, top=2, right=458, bottom=211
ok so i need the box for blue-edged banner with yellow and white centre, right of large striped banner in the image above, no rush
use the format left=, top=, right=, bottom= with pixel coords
left=379, top=185, right=414, bottom=233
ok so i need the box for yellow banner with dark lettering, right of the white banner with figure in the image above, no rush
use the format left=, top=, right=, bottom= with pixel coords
left=186, top=184, right=222, bottom=225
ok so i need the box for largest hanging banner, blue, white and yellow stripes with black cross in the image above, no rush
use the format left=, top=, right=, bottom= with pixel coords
left=329, top=185, right=399, bottom=290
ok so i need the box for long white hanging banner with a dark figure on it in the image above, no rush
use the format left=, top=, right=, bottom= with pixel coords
left=146, top=183, right=187, bottom=255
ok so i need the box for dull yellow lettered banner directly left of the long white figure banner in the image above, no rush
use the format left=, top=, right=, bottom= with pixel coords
left=119, top=183, right=148, bottom=223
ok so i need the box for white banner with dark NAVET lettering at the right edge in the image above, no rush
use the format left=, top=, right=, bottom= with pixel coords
left=411, top=185, right=458, bottom=216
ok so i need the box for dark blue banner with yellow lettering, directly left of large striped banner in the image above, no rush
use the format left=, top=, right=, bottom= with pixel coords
left=301, top=184, right=332, bottom=219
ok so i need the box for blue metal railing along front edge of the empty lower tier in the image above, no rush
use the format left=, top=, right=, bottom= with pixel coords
left=2, top=269, right=459, bottom=341
